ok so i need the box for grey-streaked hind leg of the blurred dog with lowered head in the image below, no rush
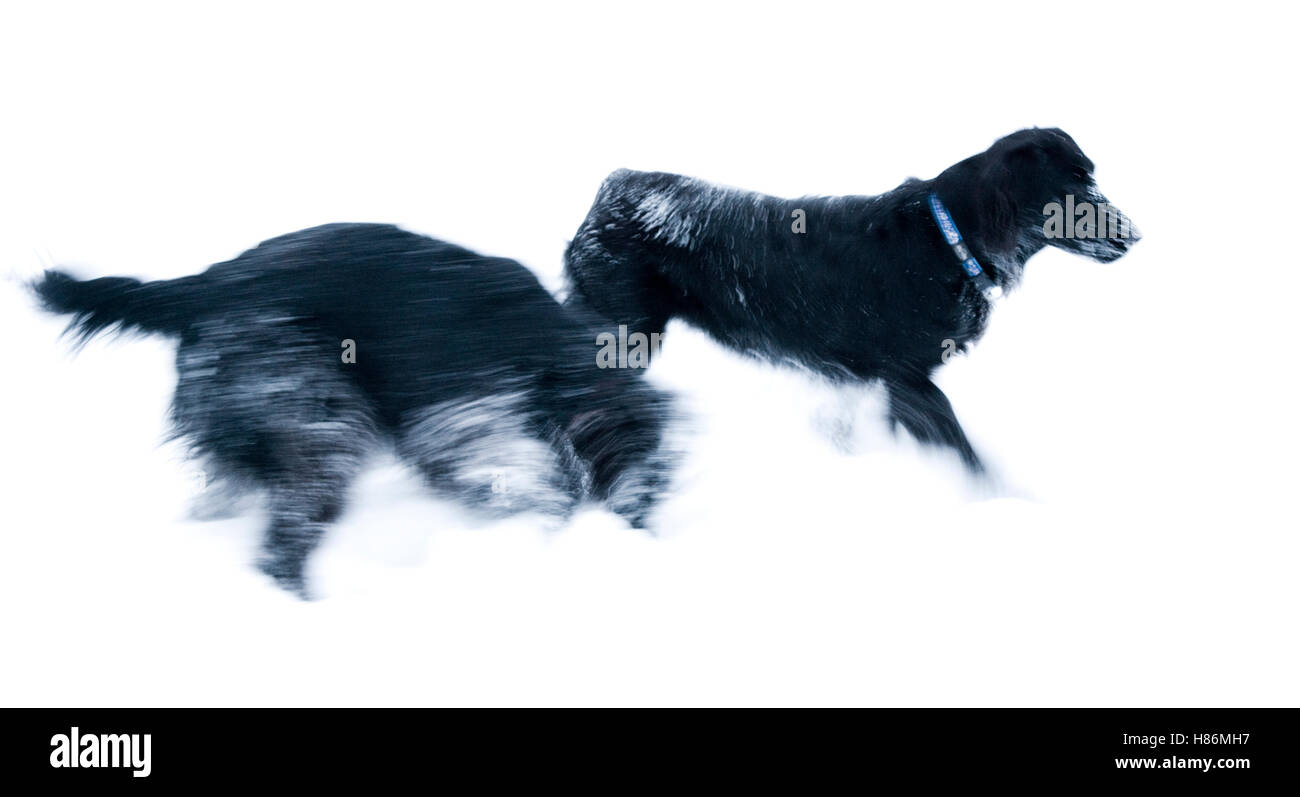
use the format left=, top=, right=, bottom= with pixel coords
left=173, top=316, right=377, bottom=597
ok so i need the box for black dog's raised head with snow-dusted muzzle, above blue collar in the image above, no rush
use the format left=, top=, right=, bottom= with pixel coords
left=980, top=127, right=1141, bottom=263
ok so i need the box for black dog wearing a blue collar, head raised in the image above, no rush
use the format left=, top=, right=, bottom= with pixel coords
left=566, top=129, right=1138, bottom=472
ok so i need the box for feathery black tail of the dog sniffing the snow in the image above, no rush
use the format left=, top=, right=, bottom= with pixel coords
left=31, top=270, right=202, bottom=342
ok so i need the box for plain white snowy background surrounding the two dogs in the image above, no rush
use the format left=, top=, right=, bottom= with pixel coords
left=0, top=1, right=1300, bottom=706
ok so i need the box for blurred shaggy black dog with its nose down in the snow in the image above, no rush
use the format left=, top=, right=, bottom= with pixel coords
left=34, top=224, right=671, bottom=594
